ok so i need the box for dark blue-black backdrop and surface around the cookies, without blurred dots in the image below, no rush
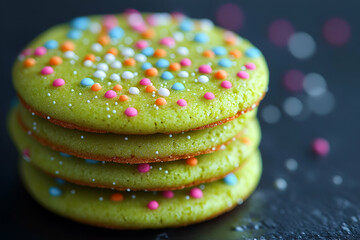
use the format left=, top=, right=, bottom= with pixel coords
left=0, top=0, right=360, bottom=239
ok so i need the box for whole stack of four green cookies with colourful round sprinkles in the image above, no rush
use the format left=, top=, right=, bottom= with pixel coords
left=9, top=10, right=268, bottom=229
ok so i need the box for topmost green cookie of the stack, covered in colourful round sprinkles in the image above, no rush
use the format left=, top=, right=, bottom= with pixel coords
left=13, top=11, right=268, bottom=134
